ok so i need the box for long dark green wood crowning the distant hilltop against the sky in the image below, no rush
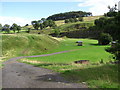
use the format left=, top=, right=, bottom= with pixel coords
left=47, top=11, right=92, bottom=21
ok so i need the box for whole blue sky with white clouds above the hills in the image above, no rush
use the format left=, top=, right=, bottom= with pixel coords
left=0, top=0, right=120, bottom=26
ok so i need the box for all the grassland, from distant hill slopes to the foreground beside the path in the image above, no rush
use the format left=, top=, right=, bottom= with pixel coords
left=0, top=16, right=119, bottom=88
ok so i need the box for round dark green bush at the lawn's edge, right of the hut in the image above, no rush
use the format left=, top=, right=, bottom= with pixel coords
left=98, top=33, right=112, bottom=45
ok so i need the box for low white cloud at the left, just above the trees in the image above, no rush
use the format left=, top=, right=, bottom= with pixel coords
left=0, top=16, right=32, bottom=26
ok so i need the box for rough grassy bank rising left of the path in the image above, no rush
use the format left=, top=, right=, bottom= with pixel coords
left=2, top=34, right=58, bottom=57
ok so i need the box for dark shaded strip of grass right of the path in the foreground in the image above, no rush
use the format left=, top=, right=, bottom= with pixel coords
left=62, top=65, right=118, bottom=83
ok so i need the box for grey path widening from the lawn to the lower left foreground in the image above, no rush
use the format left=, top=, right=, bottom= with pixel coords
left=2, top=51, right=87, bottom=88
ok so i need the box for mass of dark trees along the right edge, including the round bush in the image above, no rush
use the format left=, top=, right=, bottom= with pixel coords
left=91, top=5, right=120, bottom=61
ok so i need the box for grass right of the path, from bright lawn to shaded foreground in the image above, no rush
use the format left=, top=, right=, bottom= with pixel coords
left=19, top=38, right=118, bottom=88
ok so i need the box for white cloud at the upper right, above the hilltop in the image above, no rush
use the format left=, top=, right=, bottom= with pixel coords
left=78, top=0, right=120, bottom=15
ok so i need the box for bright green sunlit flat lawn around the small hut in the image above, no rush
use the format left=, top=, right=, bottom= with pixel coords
left=25, top=39, right=111, bottom=63
